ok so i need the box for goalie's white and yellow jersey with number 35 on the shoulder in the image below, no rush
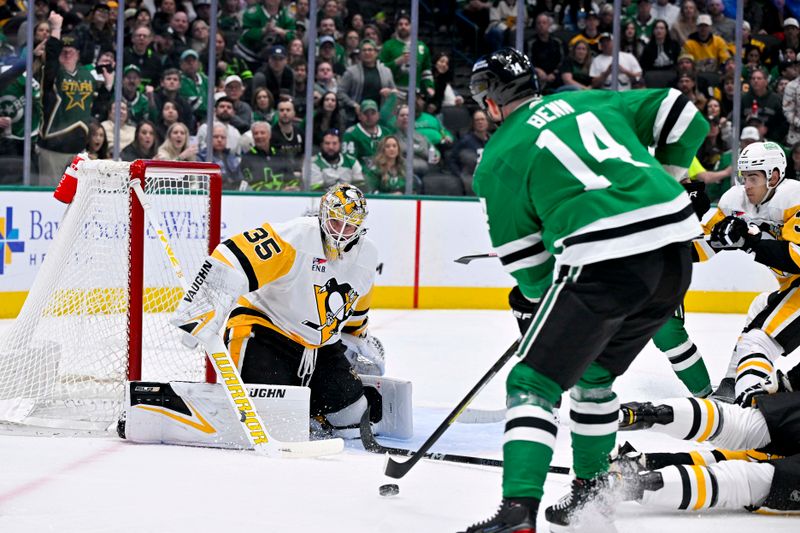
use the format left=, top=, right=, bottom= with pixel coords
left=212, top=217, right=378, bottom=349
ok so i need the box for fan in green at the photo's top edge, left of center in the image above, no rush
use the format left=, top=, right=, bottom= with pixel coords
left=235, top=0, right=295, bottom=70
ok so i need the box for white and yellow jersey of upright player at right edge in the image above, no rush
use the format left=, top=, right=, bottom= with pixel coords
left=695, top=180, right=800, bottom=287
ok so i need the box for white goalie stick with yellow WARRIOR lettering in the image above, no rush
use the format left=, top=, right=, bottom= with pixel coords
left=130, top=179, right=344, bottom=458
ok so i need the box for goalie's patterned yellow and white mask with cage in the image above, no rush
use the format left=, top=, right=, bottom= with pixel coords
left=319, top=183, right=367, bottom=259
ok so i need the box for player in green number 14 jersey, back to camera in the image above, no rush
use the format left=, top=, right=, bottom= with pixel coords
left=460, top=48, right=708, bottom=533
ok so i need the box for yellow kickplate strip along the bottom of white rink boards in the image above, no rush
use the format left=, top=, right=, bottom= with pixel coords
left=0, top=286, right=759, bottom=318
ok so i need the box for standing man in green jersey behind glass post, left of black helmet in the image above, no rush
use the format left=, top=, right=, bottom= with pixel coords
left=378, top=13, right=434, bottom=95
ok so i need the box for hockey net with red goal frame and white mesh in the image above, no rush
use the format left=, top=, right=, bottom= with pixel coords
left=0, top=161, right=221, bottom=432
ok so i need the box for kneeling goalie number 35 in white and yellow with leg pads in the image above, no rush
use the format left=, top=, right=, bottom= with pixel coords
left=119, top=184, right=413, bottom=448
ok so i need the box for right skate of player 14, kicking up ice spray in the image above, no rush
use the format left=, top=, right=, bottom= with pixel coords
left=544, top=474, right=621, bottom=533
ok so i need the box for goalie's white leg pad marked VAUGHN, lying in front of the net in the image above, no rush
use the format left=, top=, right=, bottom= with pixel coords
left=124, top=381, right=309, bottom=449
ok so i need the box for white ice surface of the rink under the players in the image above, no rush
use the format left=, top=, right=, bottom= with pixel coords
left=0, top=310, right=800, bottom=533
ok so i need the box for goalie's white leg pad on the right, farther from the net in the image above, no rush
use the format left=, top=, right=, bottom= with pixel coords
left=361, top=376, right=414, bottom=439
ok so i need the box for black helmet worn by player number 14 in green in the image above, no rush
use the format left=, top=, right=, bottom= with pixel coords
left=469, top=47, right=539, bottom=109
